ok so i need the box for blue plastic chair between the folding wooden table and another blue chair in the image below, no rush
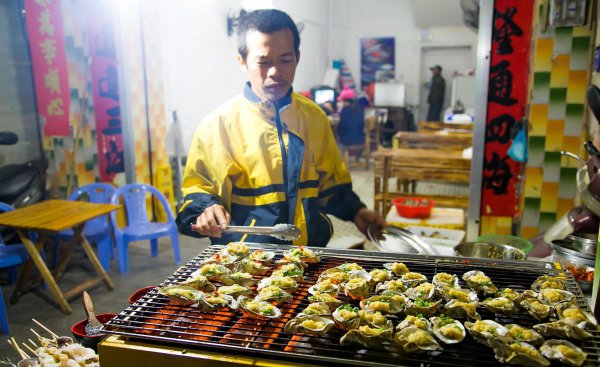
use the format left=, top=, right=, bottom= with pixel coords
left=52, top=183, right=116, bottom=271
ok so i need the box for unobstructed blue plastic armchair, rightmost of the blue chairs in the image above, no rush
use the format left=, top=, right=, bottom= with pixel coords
left=110, top=184, right=181, bottom=273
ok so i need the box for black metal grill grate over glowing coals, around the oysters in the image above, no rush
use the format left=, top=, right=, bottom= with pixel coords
left=106, top=244, right=600, bottom=366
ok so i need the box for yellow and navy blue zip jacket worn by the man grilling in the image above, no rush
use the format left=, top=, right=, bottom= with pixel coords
left=177, top=83, right=365, bottom=246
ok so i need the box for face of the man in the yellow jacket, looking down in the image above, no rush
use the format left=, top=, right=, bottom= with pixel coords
left=238, top=29, right=298, bottom=101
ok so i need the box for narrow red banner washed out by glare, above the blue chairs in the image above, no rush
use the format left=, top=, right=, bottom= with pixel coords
left=88, top=1, right=125, bottom=182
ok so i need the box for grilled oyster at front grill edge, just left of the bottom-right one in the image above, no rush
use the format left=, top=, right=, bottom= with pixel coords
left=489, top=336, right=550, bottom=366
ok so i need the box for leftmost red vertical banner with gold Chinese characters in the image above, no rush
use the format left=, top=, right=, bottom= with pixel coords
left=25, top=0, right=71, bottom=136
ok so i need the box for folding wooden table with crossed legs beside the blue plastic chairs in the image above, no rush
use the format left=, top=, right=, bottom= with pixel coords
left=0, top=200, right=120, bottom=314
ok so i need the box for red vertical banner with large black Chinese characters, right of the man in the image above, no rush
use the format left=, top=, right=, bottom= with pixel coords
left=481, top=0, right=534, bottom=217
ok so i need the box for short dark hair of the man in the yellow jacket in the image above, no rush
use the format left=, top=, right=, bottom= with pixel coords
left=237, top=9, right=300, bottom=60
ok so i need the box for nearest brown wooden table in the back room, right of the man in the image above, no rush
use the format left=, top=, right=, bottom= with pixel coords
left=373, top=148, right=471, bottom=215
